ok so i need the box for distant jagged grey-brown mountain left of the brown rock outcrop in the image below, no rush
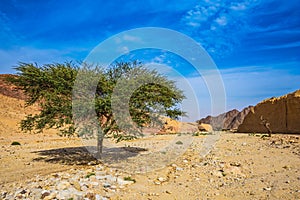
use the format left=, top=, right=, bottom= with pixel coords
left=197, top=106, right=253, bottom=130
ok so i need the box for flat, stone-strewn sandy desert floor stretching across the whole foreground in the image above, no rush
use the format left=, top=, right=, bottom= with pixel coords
left=0, top=133, right=300, bottom=199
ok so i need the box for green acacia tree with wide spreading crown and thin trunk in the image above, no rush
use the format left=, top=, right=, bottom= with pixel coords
left=8, top=61, right=185, bottom=158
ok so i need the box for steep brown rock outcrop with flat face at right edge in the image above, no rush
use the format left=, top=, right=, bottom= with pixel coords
left=238, top=90, right=300, bottom=133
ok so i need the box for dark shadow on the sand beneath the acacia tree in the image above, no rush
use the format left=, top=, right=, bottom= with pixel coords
left=31, top=146, right=147, bottom=165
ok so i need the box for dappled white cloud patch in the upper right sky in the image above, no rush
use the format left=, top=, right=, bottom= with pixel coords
left=182, top=0, right=258, bottom=57
